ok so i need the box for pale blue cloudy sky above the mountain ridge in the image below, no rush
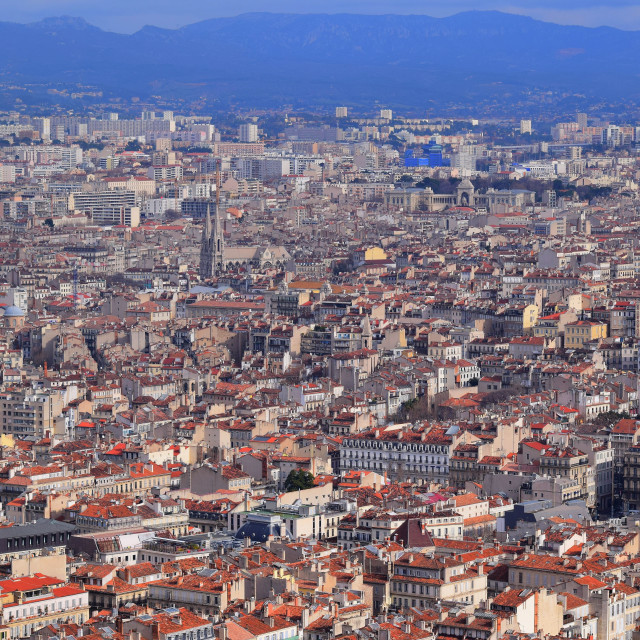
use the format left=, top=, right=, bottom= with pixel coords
left=0, top=0, right=640, bottom=33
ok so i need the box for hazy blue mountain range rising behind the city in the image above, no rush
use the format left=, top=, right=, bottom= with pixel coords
left=0, top=11, right=640, bottom=107
